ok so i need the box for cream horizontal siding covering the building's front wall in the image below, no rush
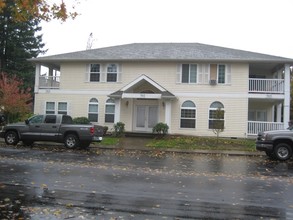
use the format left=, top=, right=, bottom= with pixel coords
left=35, top=62, right=249, bottom=137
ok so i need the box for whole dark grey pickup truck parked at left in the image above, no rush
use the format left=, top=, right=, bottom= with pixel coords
left=0, top=115, right=103, bottom=148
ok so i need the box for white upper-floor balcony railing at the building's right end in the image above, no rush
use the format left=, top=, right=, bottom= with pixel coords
left=249, top=79, right=284, bottom=94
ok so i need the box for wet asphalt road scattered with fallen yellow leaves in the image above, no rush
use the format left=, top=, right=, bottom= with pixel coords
left=0, top=146, right=293, bottom=219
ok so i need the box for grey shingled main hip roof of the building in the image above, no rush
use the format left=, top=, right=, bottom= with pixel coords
left=30, top=43, right=293, bottom=63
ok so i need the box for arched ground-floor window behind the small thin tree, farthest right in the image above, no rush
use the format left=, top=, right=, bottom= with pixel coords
left=209, top=102, right=224, bottom=129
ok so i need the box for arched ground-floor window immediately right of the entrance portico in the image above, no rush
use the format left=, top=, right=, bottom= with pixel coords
left=180, top=101, right=196, bottom=128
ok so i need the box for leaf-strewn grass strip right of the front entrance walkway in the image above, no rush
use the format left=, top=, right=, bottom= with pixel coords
left=147, top=136, right=255, bottom=151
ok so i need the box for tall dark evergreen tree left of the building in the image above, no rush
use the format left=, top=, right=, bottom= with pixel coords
left=0, top=1, right=45, bottom=88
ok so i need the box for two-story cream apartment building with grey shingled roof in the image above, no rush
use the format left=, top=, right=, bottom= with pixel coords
left=31, top=43, right=293, bottom=137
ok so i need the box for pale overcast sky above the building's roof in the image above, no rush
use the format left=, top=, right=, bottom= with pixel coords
left=42, top=0, right=293, bottom=58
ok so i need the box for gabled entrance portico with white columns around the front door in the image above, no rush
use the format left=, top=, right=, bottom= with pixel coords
left=109, top=75, right=176, bottom=132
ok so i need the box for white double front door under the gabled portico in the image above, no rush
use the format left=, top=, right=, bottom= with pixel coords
left=135, top=105, right=158, bottom=132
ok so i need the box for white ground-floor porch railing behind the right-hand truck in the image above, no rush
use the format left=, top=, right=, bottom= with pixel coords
left=247, top=121, right=284, bottom=135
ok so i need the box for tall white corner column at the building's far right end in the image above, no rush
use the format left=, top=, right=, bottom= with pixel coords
left=283, top=64, right=290, bottom=128
